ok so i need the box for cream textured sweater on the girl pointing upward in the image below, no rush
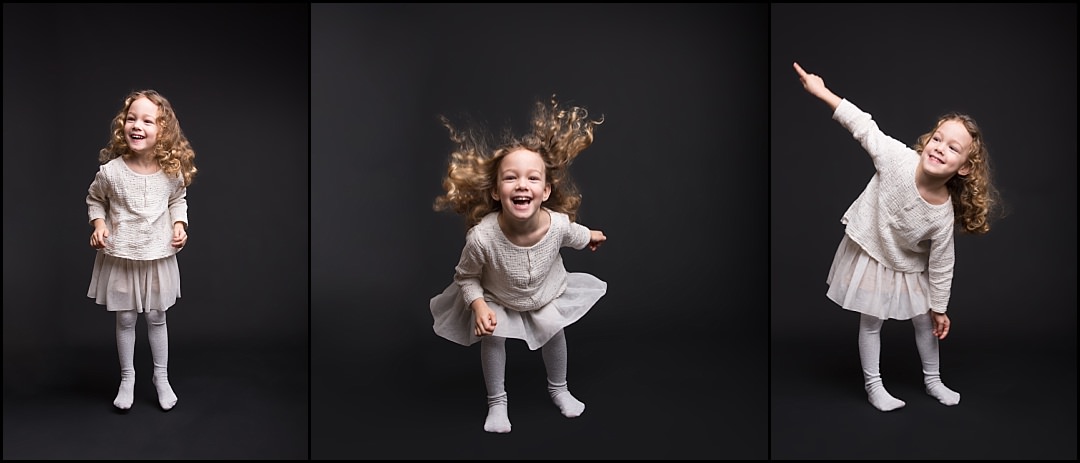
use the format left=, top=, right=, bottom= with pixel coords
left=833, top=99, right=955, bottom=313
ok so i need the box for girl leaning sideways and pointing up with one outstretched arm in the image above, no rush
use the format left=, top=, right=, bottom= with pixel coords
left=794, top=63, right=996, bottom=411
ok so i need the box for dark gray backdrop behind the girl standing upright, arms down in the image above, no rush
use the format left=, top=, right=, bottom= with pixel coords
left=3, top=3, right=310, bottom=460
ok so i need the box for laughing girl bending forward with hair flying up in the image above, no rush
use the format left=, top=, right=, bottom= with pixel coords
left=430, top=97, right=607, bottom=433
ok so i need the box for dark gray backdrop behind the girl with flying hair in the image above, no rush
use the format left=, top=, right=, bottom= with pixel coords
left=311, top=4, right=768, bottom=459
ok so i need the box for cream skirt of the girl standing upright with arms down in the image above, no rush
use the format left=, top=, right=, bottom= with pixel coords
left=86, top=251, right=180, bottom=313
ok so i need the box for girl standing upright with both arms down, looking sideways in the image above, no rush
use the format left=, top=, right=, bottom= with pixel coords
left=86, top=90, right=197, bottom=410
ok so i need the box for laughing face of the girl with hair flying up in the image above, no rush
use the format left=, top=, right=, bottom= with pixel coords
left=491, top=149, right=551, bottom=221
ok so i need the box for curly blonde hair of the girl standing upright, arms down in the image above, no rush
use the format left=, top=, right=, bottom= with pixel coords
left=98, top=90, right=199, bottom=186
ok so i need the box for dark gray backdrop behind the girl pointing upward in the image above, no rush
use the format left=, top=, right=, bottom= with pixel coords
left=770, top=3, right=1077, bottom=459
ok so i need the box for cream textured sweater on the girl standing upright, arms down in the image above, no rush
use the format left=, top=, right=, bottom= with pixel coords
left=86, top=158, right=188, bottom=260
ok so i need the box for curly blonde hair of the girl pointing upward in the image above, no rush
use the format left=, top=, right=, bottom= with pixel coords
left=915, top=112, right=1000, bottom=234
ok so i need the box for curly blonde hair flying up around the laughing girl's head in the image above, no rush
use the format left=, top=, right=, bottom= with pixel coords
left=434, top=95, right=604, bottom=228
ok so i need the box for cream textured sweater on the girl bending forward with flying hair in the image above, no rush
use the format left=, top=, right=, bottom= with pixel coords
left=454, top=209, right=590, bottom=312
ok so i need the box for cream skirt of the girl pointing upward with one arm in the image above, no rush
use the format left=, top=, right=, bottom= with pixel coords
left=825, top=234, right=930, bottom=319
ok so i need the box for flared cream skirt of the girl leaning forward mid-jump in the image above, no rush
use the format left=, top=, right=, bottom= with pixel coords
left=430, top=273, right=607, bottom=350
